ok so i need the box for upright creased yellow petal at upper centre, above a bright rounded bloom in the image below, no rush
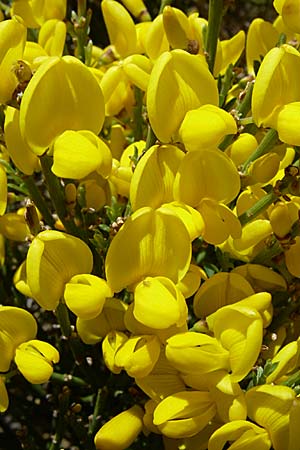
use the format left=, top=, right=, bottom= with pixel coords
left=147, top=50, right=218, bottom=143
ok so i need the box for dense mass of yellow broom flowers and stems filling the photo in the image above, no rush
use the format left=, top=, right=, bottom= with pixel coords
left=0, top=0, right=300, bottom=450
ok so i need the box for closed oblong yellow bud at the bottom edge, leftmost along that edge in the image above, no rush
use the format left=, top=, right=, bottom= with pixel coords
left=95, top=405, right=144, bottom=450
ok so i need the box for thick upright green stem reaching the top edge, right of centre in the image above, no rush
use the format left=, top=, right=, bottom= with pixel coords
left=206, top=0, right=223, bottom=74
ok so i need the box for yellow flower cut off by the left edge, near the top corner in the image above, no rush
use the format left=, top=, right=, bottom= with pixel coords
left=0, top=17, right=26, bottom=103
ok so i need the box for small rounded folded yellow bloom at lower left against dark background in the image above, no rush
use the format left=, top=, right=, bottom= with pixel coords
left=15, top=339, right=59, bottom=384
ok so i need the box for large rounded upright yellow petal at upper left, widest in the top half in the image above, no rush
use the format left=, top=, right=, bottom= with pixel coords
left=20, top=56, right=104, bottom=155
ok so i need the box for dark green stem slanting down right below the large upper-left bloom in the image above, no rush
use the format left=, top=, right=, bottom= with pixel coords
left=37, top=155, right=81, bottom=237
